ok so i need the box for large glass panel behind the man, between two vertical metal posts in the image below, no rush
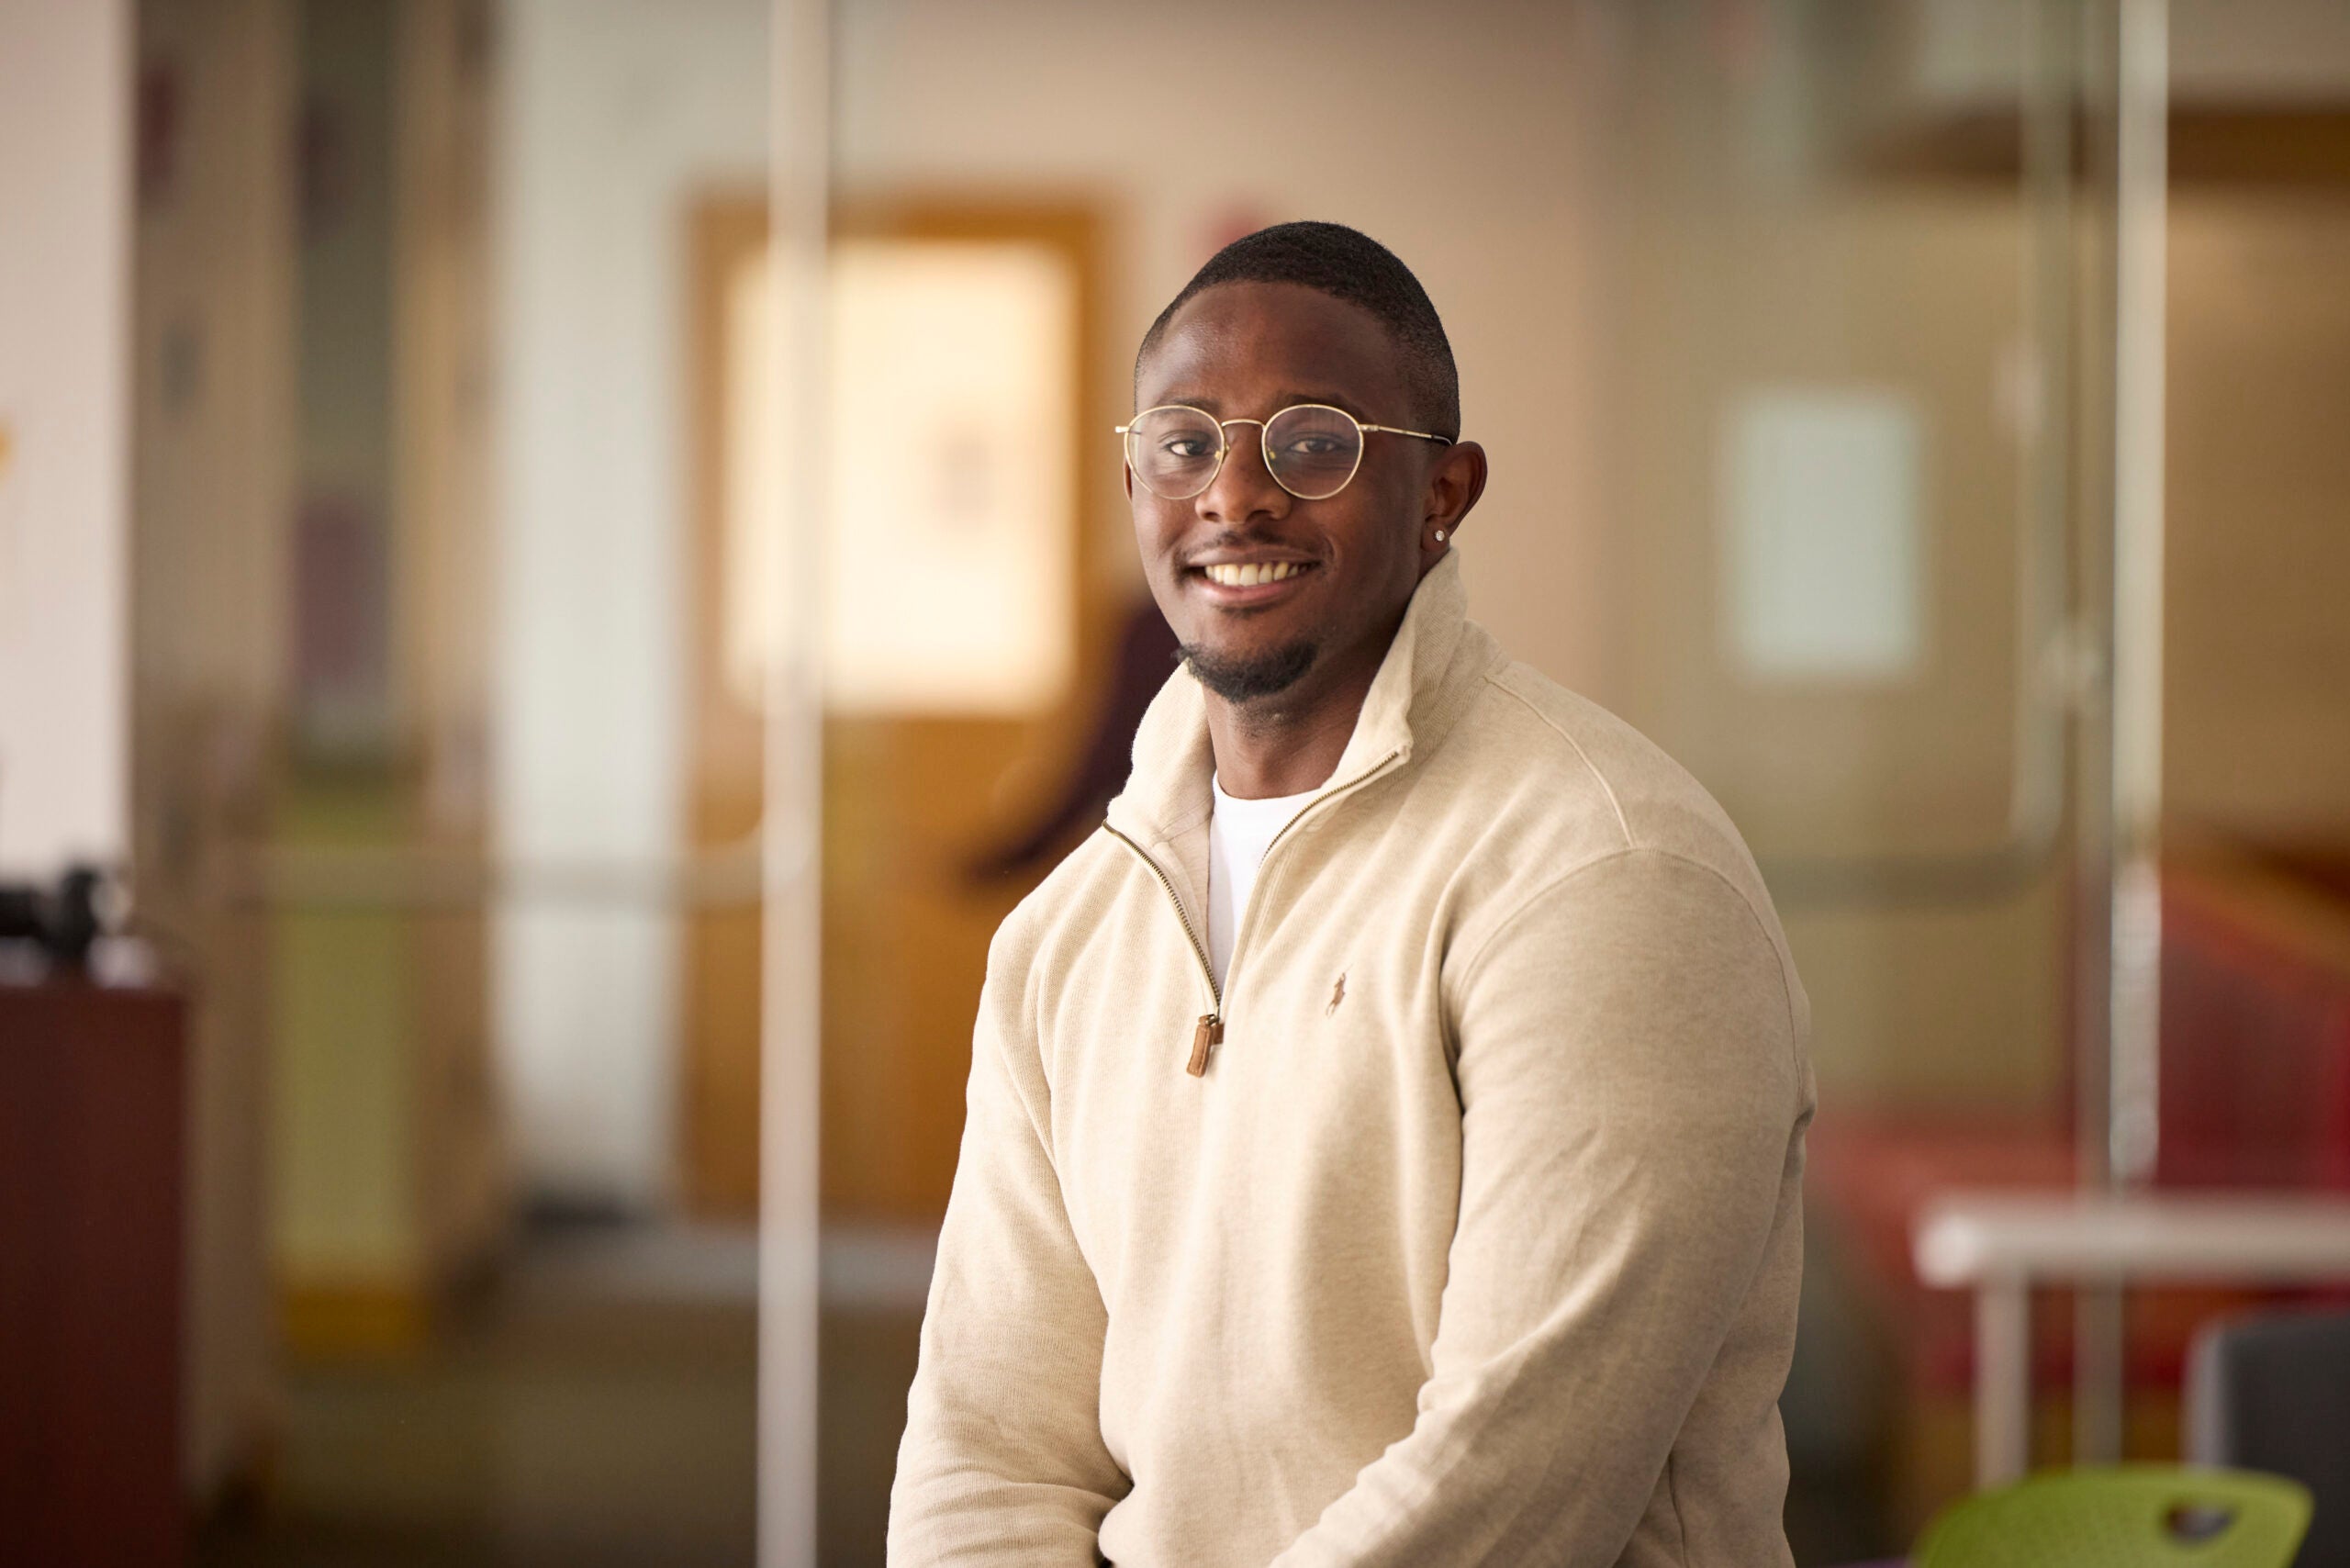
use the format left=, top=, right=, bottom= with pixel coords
left=820, top=0, right=2103, bottom=1561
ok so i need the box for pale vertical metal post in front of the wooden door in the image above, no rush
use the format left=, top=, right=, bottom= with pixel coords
left=756, top=0, right=832, bottom=1568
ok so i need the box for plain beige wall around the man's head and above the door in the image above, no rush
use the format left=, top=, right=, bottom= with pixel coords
left=834, top=0, right=1612, bottom=684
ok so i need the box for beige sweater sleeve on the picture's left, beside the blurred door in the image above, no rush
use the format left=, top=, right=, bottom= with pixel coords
left=889, top=938, right=1130, bottom=1568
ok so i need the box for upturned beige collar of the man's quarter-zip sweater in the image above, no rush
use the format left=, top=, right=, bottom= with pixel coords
left=1109, top=550, right=1472, bottom=844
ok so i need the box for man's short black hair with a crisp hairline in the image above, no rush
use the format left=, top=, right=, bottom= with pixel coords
left=1135, top=221, right=1461, bottom=437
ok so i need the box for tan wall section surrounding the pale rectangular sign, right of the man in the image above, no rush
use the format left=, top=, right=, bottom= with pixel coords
left=1603, top=172, right=2065, bottom=1110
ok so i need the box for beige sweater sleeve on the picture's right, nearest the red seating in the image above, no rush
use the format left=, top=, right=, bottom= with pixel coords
left=1276, top=848, right=1803, bottom=1568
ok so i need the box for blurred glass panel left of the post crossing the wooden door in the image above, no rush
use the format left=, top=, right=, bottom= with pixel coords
left=135, top=0, right=771, bottom=1568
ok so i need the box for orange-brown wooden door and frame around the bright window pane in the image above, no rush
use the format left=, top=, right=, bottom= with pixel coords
left=684, top=197, right=1121, bottom=1223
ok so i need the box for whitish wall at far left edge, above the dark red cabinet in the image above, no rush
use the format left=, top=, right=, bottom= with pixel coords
left=0, top=0, right=131, bottom=877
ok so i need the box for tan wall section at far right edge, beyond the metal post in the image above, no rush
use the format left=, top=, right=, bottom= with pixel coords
left=2162, top=190, right=2350, bottom=854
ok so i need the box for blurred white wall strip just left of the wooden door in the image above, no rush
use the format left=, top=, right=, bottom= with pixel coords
left=491, top=0, right=768, bottom=1204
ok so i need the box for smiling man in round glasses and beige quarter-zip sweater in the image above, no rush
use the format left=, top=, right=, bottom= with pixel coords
left=890, top=223, right=1812, bottom=1568
